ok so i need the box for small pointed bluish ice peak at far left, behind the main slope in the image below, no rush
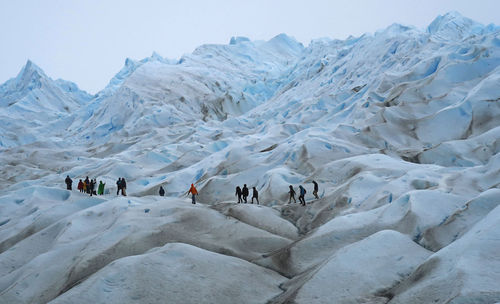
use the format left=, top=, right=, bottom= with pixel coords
left=0, top=60, right=92, bottom=147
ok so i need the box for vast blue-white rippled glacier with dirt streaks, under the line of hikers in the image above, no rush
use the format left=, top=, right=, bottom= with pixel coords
left=0, top=13, right=500, bottom=303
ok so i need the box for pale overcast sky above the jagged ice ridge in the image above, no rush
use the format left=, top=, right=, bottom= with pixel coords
left=0, top=0, right=500, bottom=93
